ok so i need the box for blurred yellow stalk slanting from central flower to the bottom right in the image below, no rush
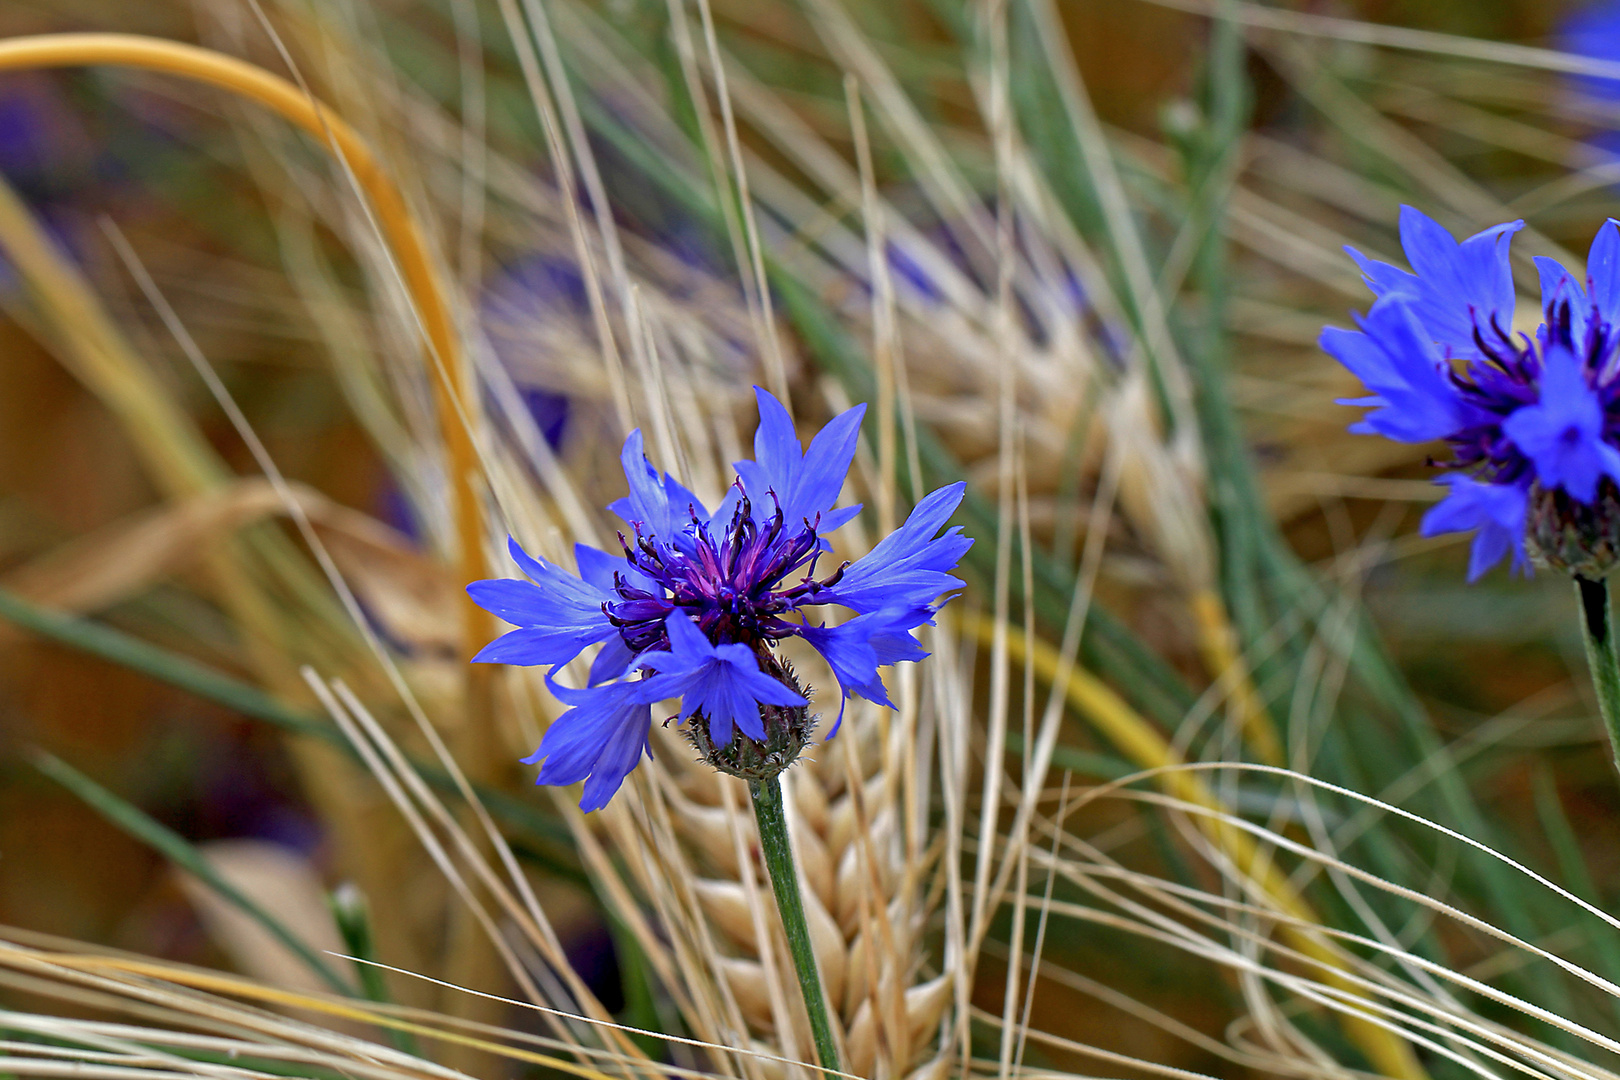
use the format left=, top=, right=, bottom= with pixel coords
left=962, top=612, right=1429, bottom=1080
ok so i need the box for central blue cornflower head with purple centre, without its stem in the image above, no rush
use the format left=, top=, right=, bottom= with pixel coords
left=467, top=389, right=972, bottom=811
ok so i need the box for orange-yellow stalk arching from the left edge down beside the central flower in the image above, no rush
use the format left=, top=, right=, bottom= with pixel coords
left=0, top=34, right=494, bottom=670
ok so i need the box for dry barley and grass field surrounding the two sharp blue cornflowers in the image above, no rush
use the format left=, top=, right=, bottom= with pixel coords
left=0, top=0, right=1620, bottom=1080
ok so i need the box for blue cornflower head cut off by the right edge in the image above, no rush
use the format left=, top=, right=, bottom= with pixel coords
left=1322, top=207, right=1620, bottom=580
